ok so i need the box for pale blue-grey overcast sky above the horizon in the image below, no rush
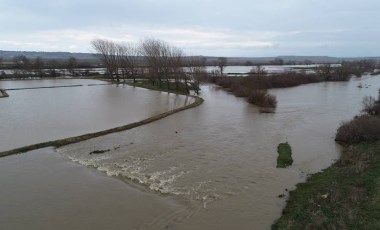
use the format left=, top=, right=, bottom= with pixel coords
left=0, top=0, right=380, bottom=57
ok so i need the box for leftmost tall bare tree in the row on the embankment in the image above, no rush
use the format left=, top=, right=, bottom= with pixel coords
left=91, top=39, right=120, bottom=82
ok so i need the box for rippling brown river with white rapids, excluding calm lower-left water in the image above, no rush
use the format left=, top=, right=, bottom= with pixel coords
left=58, top=77, right=380, bottom=229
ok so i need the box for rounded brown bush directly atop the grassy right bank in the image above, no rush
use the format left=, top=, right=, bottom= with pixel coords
left=335, top=115, right=380, bottom=145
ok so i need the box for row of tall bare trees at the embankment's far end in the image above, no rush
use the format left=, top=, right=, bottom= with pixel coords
left=91, top=38, right=206, bottom=91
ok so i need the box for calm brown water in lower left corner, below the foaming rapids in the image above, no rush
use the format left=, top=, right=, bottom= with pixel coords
left=0, top=148, right=178, bottom=230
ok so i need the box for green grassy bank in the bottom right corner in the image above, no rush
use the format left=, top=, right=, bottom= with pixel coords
left=272, top=142, right=380, bottom=229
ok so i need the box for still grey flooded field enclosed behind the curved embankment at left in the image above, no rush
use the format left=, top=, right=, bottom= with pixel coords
left=0, top=80, right=193, bottom=151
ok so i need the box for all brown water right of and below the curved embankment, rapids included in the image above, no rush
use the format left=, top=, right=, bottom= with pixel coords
left=0, top=76, right=380, bottom=229
